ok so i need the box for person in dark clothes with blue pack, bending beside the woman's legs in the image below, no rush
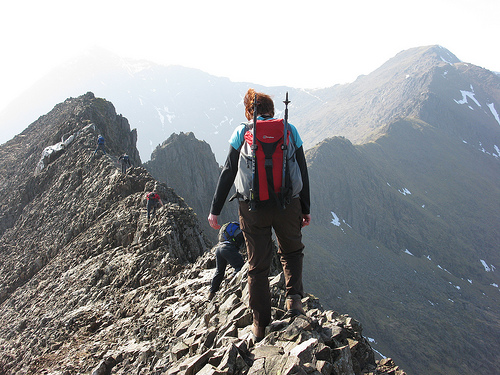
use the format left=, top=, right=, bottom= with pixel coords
left=208, top=222, right=245, bottom=300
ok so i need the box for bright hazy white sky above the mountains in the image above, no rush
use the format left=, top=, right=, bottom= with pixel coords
left=0, top=0, right=500, bottom=110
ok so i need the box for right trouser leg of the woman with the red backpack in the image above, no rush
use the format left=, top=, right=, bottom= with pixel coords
left=273, top=198, right=304, bottom=297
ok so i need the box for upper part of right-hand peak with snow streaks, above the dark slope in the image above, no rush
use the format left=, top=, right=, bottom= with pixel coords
left=294, top=46, right=500, bottom=155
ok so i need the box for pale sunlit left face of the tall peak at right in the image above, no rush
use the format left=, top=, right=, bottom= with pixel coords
left=292, top=46, right=459, bottom=148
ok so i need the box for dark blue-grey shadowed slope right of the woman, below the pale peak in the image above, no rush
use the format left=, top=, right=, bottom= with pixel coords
left=304, top=119, right=500, bottom=374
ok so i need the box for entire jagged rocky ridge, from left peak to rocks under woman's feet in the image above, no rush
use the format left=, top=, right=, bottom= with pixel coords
left=0, top=93, right=404, bottom=375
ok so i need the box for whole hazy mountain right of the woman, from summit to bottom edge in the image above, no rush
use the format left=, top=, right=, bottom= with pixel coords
left=298, top=47, right=500, bottom=374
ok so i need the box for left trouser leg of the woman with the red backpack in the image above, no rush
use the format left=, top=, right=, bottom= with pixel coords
left=239, top=202, right=273, bottom=331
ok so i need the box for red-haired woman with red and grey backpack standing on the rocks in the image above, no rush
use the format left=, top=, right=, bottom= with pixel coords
left=208, top=89, right=311, bottom=341
